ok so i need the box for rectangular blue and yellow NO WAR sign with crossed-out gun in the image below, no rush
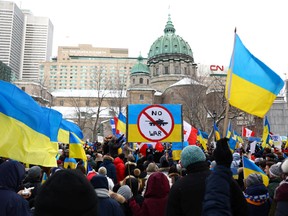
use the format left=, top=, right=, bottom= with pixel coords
left=127, top=104, right=183, bottom=143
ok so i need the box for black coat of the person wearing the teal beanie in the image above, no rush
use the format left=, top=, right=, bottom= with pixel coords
left=167, top=162, right=247, bottom=216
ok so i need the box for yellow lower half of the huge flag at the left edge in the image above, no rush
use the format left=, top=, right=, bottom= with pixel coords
left=0, top=113, right=58, bottom=167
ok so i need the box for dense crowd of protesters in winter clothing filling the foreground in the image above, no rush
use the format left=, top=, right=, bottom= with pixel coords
left=0, top=136, right=288, bottom=216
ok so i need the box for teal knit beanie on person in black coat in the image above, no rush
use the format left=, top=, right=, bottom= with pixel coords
left=181, top=145, right=206, bottom=168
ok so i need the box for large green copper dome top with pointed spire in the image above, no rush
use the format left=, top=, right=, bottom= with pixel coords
left=148, top=14, right=193, bottom=58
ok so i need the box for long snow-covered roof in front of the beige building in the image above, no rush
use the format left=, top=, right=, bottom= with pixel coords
left=51, top=89, right=127, bottom=98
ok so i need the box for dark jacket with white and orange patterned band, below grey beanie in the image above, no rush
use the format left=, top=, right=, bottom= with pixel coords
left=244, top=184, right=271, bottom=216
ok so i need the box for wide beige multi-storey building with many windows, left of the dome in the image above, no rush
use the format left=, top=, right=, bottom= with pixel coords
left=39, top=44, right=141, bottom=91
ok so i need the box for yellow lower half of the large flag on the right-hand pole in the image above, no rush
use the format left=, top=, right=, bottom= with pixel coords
left=225, top=72, right=277, bottom=118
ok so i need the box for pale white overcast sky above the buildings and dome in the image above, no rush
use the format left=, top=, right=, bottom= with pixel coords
left=15, top=0, right=288, bottom=78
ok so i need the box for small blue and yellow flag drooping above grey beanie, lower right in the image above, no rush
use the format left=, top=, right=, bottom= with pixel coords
left=242, top=157, right=269, bottom=187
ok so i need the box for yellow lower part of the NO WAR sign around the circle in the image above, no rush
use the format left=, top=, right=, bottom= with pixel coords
left=128, top=124, right=182, bottom=142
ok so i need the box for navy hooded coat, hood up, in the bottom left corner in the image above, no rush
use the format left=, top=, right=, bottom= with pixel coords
left=0, top=160, right=31, bottom=216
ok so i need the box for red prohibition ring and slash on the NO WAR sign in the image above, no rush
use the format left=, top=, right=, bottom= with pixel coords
left=137, top=105, right=174, bottom=142
